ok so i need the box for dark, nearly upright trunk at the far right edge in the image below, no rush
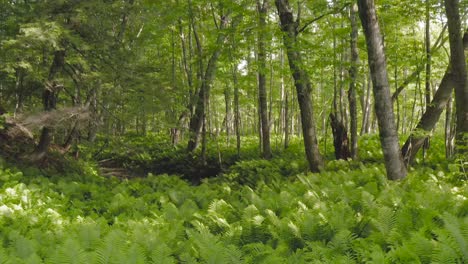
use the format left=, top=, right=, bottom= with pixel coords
left=445, top=0, right=468, bottom=157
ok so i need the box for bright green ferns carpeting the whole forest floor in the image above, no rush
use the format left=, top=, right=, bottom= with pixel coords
left=0, top=136, right=468, bottom=264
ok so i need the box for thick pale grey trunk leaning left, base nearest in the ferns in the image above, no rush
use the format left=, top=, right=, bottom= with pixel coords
left=358, top=0, right=407, bottom=180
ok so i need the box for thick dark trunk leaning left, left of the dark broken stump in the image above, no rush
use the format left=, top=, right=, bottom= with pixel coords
left=275, top=0, right=323, bottom=172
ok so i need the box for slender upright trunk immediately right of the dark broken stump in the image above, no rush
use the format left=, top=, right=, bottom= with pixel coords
left=348, top=4, right=359, bottom=159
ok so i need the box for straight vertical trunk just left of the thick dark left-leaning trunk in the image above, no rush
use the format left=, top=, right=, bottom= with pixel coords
left=257, top=0, right=271, bottom=159
